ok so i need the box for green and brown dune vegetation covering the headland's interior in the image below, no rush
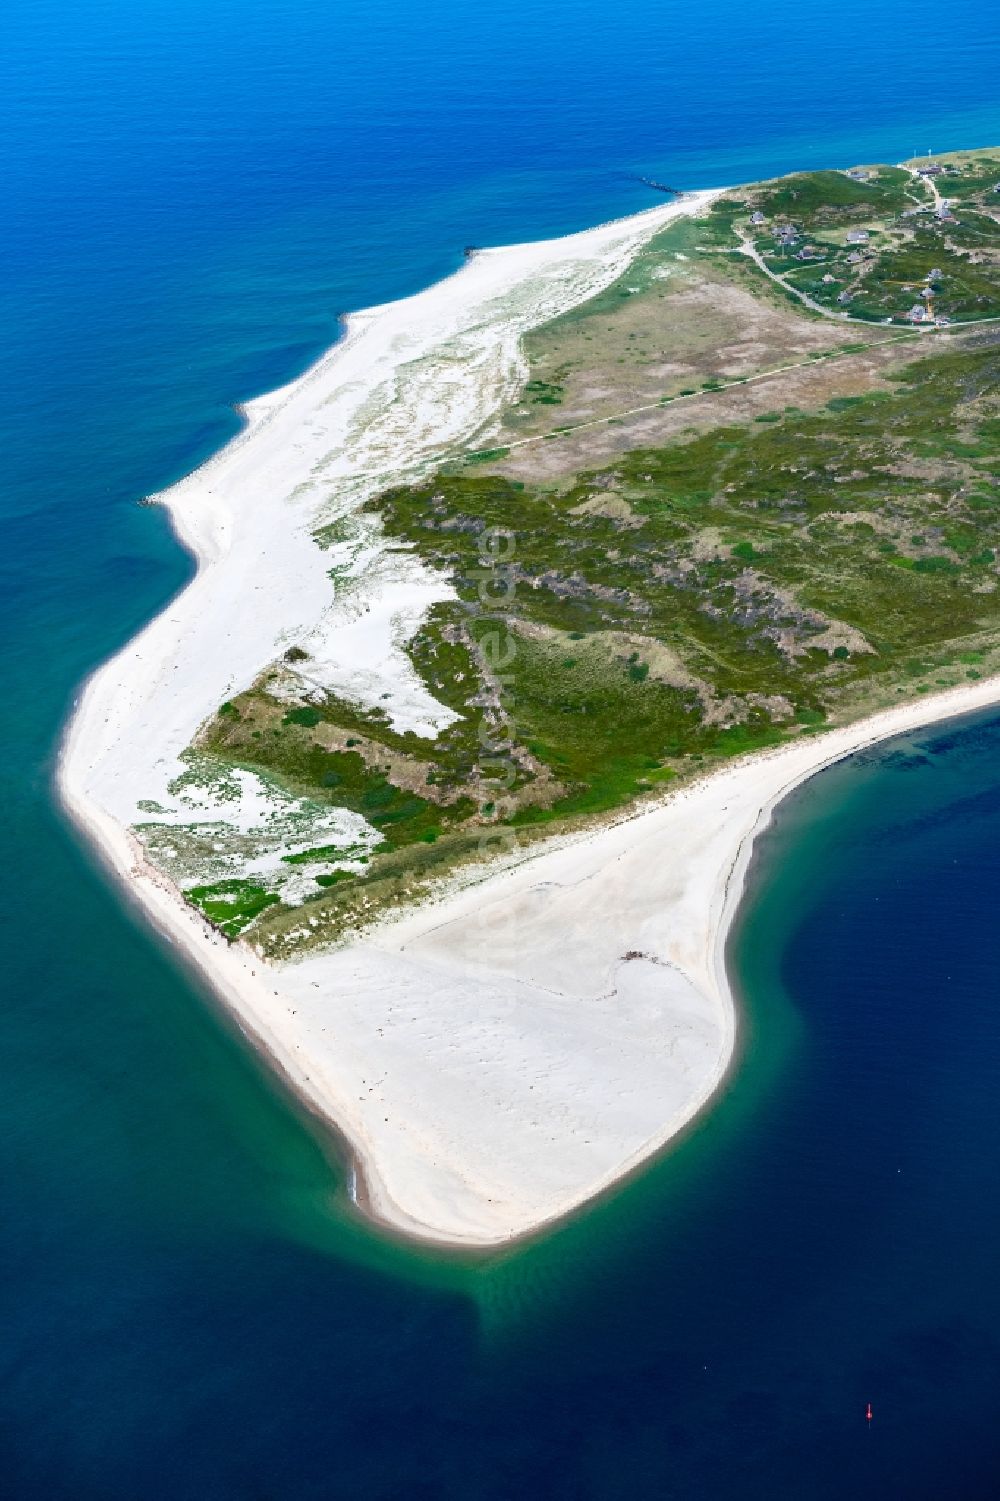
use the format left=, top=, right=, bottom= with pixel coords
left=159, top=153, right=1000, bottom=956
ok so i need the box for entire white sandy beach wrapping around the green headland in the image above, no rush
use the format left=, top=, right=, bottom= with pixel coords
left=59, top=195, right=1000, bottom=1246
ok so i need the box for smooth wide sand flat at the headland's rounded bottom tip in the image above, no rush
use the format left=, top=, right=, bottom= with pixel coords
left=140, top=678, right=1000, bottom=1246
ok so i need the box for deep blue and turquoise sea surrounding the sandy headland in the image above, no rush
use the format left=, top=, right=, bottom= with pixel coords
left=0, top=0, right=1000, bottom=1501
